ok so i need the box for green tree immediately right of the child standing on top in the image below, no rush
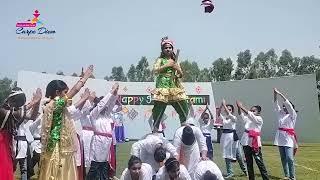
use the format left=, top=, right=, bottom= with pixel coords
left=180, top=60, right=200, bottom=82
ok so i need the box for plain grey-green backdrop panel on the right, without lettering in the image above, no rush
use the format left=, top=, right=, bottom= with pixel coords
left=212, top=75, right=320, bottom=142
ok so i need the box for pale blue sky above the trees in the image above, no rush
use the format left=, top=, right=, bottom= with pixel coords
left=0, top=0, right=320, bottom=79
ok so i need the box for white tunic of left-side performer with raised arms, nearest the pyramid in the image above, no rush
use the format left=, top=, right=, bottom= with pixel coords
left=89, top=93, right=117, bottom=162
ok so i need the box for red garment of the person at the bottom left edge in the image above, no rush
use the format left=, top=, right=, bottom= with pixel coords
left=0, top=129, right=14, bottom=180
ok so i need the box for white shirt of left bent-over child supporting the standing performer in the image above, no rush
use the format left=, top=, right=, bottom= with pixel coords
left=131, top=134, right=178, bottom=174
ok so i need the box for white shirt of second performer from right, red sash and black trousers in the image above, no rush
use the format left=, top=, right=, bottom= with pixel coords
left=240, top=111, right=263, bottom=147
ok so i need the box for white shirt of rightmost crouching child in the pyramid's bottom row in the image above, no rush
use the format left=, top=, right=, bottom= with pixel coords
left=192, top=160, right=224, bottom=180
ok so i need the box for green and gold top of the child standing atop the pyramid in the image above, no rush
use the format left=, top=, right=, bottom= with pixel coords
left=154, top=58, right=179, bottom=88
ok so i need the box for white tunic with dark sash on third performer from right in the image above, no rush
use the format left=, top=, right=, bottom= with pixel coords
left=220, top=114, right=239, bottom=160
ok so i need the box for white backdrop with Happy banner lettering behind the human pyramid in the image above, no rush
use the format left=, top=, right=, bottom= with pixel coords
left=18, top=71, right=216, bottom=139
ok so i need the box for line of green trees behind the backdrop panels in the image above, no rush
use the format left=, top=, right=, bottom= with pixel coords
left=0, top=49, right=320, bottom=105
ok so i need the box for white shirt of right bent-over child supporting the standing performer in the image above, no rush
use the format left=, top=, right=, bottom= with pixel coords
left=173, top=126, right=208, bottom=174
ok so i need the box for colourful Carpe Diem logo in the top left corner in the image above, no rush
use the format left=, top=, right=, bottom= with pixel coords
left=16, top=10, right=56, bottom=39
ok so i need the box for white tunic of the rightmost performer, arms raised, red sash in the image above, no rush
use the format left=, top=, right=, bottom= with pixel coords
left=274, top=99, right=297, bottom=147
